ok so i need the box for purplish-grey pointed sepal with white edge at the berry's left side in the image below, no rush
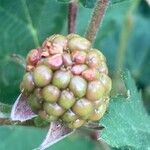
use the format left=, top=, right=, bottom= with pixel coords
left=11, top=93, right=37, bottom=122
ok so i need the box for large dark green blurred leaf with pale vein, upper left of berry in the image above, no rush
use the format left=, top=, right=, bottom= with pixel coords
left=0, top=0, right=67, bottom=104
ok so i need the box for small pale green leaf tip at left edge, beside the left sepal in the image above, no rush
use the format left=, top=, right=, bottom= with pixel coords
left=0, top=103, right=11, bottom=118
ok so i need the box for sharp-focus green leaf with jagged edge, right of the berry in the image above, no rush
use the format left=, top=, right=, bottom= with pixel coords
left=100, top=72, right=150, bottom=150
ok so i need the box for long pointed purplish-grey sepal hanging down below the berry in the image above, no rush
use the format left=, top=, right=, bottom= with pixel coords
left=37, top=121, right=73, bottom=150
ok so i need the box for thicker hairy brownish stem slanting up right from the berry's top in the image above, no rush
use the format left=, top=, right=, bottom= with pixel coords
left=85, top=0, right=109, bottom=42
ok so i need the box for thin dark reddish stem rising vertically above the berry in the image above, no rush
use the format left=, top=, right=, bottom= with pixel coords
left=68, top=0, right=77, bottom=33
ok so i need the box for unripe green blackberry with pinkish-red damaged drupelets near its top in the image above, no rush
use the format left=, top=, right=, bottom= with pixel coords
left=20, top=34, right=111, bottom=128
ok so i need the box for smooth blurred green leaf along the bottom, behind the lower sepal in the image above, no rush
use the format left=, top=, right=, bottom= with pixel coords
left=0, top=126, right=102, bottom=150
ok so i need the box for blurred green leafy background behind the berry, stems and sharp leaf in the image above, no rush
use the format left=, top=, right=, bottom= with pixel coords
left=0, top=0, right=150, bottom=150
